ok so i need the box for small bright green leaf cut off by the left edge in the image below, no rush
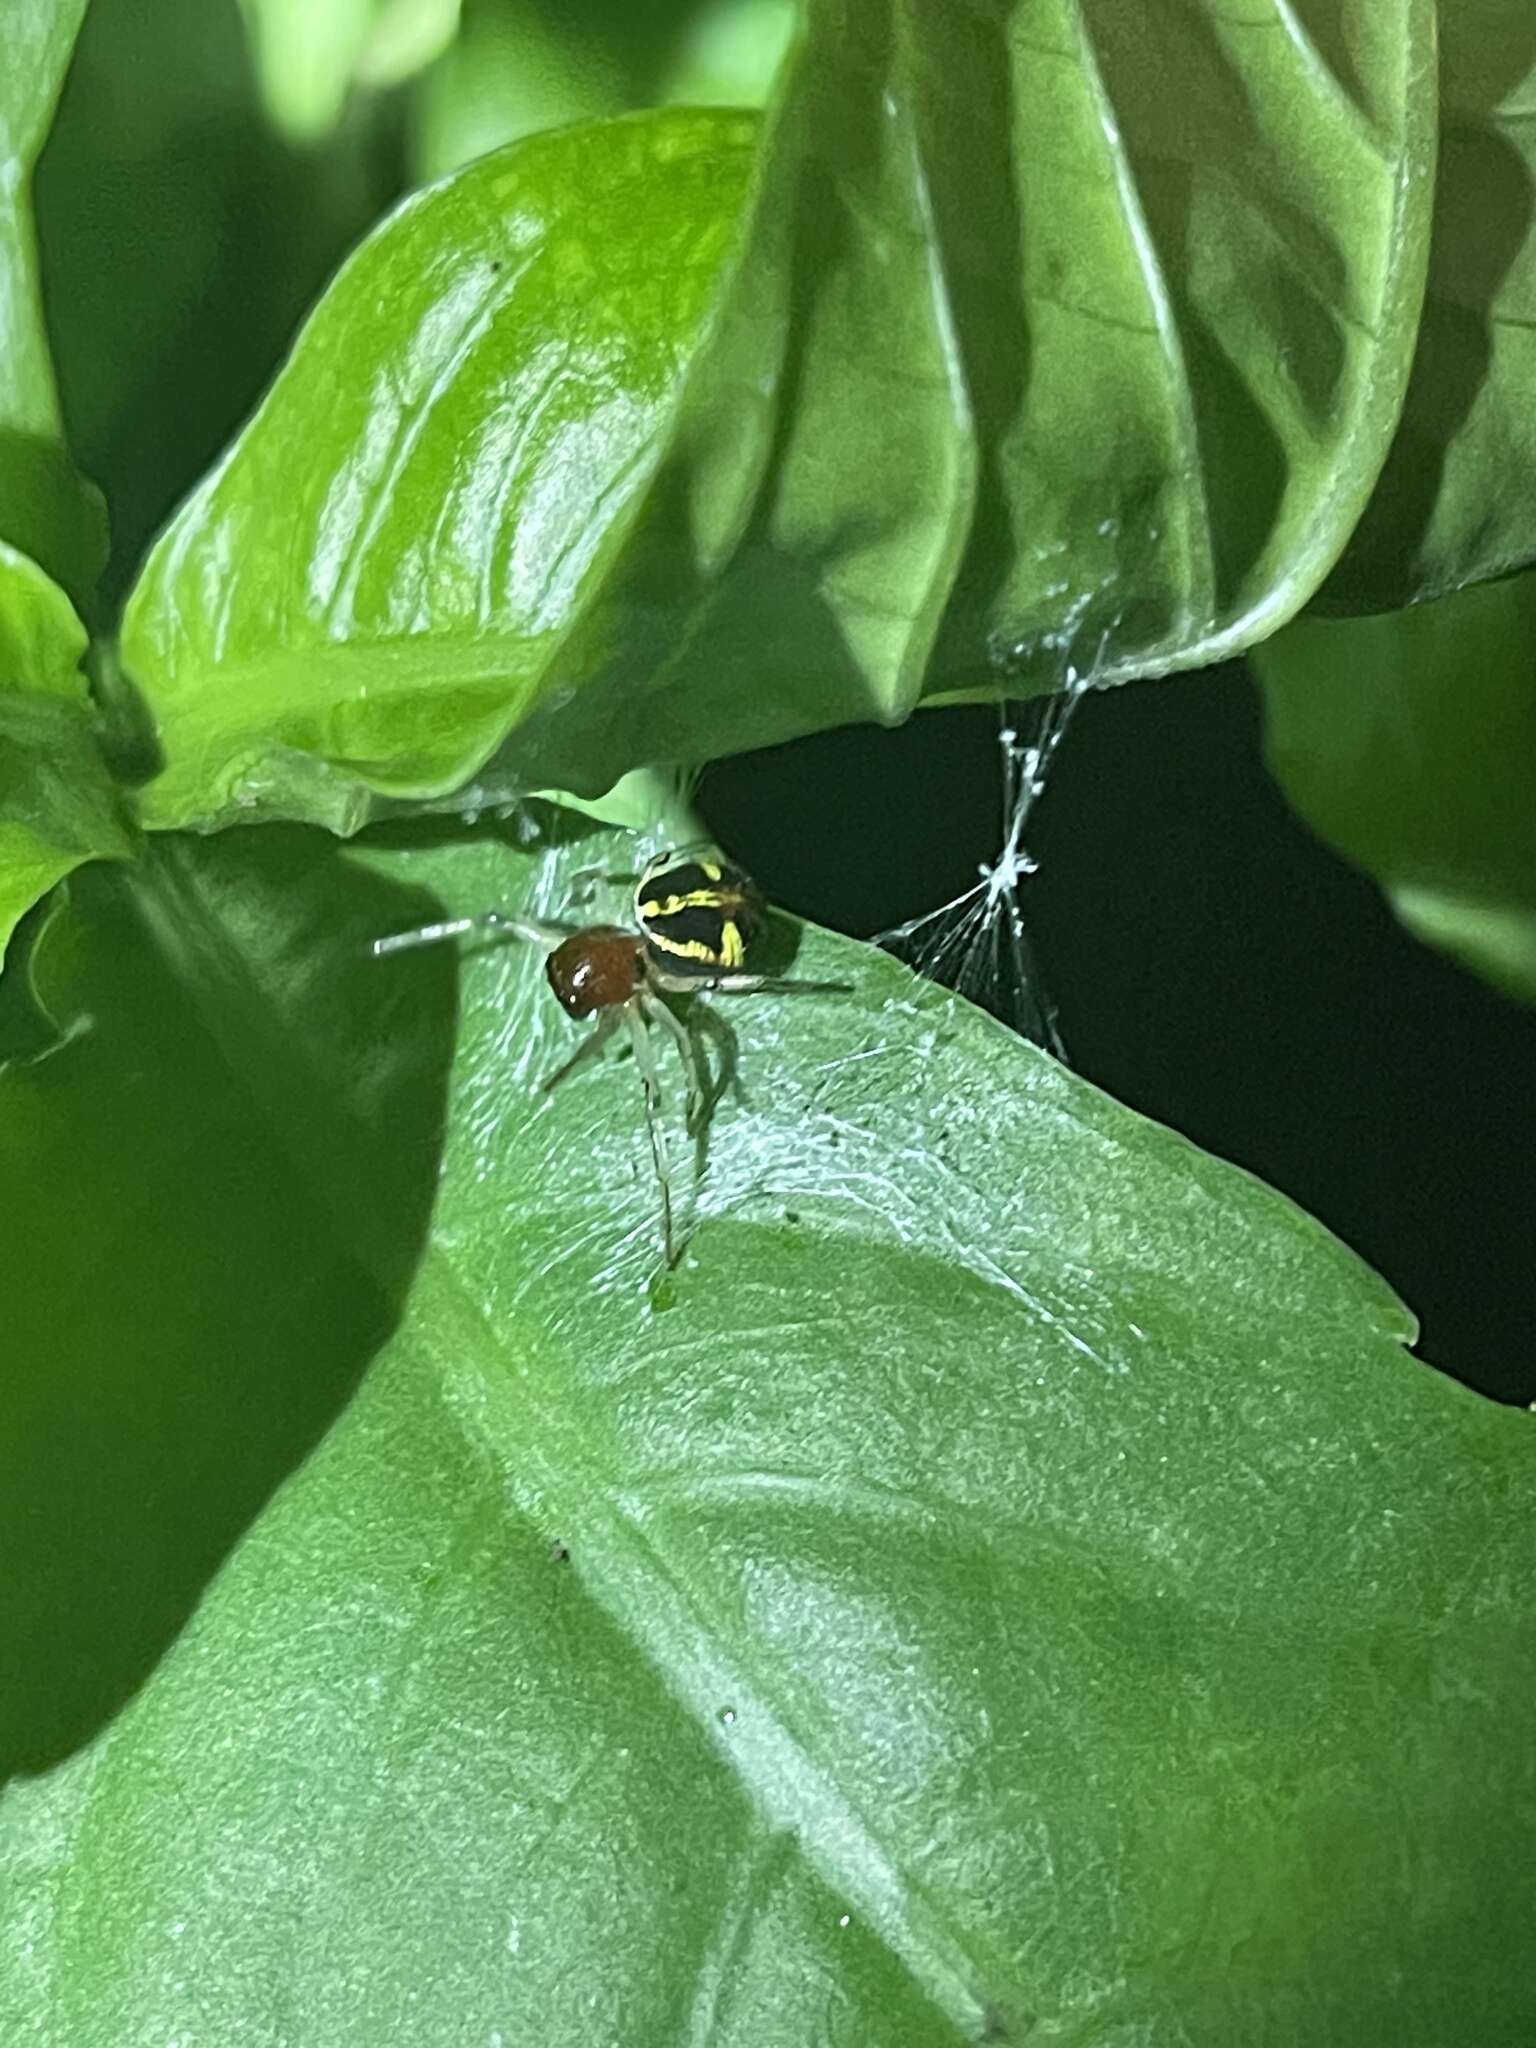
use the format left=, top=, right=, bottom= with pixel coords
left=0, top=541, right=133, bottom=963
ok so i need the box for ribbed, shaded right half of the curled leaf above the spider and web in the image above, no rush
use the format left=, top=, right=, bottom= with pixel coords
left=541, top=0, right=1434, bottom=782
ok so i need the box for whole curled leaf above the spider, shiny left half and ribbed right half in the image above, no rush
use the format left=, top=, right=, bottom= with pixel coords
left=127, top=0, right=1434, bottom=823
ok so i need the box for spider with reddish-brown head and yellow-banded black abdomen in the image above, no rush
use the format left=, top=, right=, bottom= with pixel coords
left=373, top=848, right=850, bottom=1268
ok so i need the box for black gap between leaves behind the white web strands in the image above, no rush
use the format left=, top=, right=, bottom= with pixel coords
left=702, top=679, right=1536, bottom=1401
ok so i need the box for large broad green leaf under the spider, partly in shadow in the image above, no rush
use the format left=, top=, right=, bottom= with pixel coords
left=0, top=819, right=1536, bottom=2048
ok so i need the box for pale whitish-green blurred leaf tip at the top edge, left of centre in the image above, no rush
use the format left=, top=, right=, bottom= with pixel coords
left=240, top=0, right=459, bottom=143
